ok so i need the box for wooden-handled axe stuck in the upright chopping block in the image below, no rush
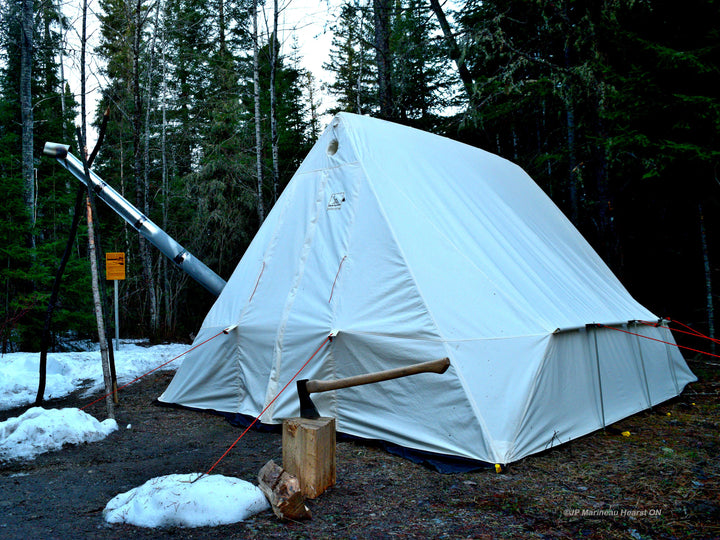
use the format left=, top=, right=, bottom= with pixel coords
left=297, top=358, right=450, bottom=418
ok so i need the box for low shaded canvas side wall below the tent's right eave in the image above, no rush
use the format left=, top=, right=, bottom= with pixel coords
left=507, top=324, right=696, bottom=461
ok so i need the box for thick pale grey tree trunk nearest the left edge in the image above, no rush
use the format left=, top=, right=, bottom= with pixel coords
left=20, top=0, right=35, bottom=248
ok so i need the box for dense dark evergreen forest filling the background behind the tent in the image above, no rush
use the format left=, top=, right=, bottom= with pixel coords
left=0, top=0, right=720, bottom=352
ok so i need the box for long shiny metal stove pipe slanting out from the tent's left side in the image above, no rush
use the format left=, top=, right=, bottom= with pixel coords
left=43, top=142, right=225, bottom=296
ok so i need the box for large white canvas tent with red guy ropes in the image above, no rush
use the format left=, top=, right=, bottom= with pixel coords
left=160, top=113, right=695, bottom=463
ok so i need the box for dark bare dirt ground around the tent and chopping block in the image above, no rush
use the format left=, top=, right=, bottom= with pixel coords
left=0, top=361, right=720, bottom=539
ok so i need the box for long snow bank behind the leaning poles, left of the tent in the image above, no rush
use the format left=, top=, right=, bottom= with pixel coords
left=0, top=341, right=189, bottom=410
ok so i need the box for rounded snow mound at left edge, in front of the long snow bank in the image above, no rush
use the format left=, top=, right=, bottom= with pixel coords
left=0, top=407, right=118, bottom=460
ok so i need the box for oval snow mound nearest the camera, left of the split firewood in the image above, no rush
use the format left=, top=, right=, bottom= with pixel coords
left=103, top=473, right=270, bottom=527
